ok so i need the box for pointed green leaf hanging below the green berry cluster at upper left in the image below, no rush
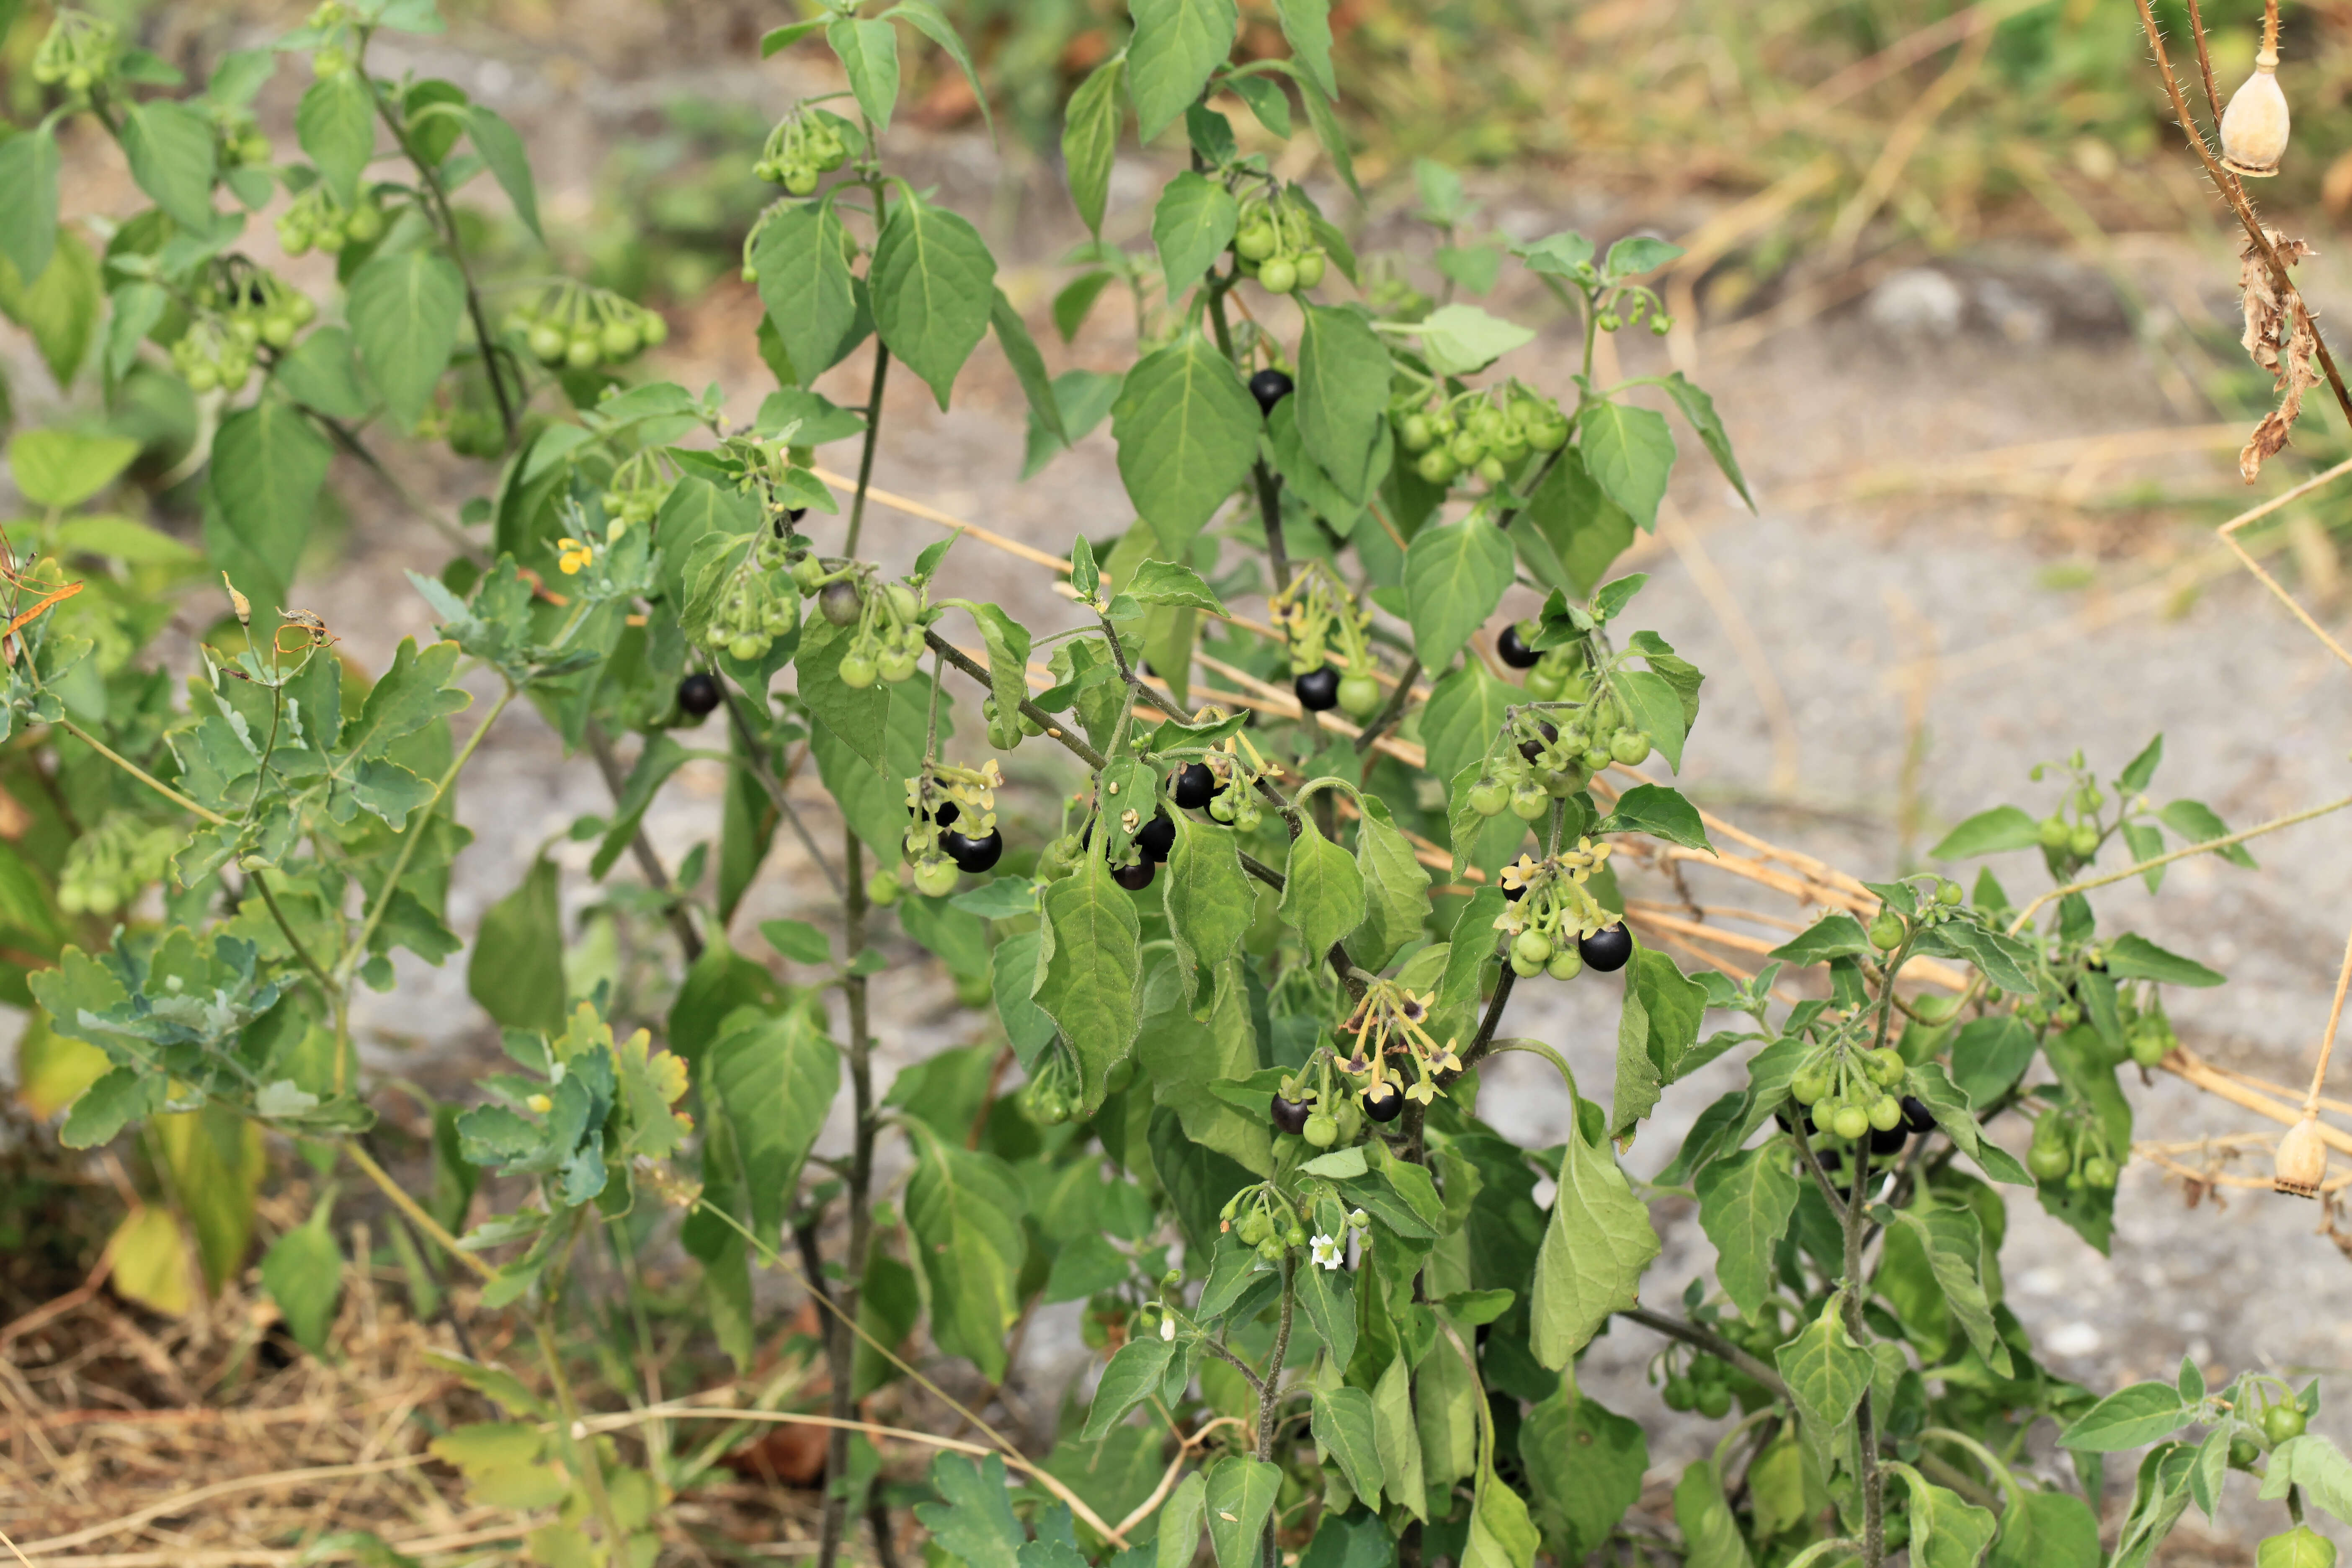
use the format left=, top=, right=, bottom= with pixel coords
left=205, top=397, right=334, bottom=625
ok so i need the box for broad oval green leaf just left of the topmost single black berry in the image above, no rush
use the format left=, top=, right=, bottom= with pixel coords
left=1110, top=331, right=1261, bottom=557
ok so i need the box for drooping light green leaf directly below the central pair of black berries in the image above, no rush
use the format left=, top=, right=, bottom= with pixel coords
left=1030, top=856, right=1143, bottom=1117
